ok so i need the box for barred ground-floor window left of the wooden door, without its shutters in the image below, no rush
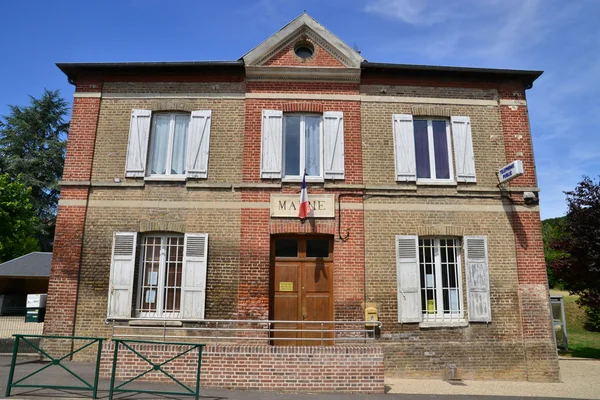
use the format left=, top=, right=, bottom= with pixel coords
left=137, top=235, right=184, bottom=318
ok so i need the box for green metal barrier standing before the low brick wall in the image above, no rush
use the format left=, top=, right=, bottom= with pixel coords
left=108, top=339, right=206, bottom=400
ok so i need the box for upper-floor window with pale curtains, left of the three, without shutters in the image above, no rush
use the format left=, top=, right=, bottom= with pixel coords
left=147, top=113, right=190, bottom=176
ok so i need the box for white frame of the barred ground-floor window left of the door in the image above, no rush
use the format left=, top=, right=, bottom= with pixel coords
left=135, top=233, right=185, bottom=319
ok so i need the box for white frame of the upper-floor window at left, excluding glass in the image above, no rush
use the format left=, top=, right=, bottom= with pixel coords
left=144, top=112, right=192, bottom=180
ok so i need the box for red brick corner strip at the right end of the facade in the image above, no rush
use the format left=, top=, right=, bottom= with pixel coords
left=500, top=87, right=558, bottom=381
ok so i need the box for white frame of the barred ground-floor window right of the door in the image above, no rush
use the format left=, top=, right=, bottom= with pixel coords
left=417, top=236, right=465, bottom=324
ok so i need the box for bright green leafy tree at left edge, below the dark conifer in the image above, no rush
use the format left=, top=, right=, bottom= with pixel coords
left=0, top=174, right=39, bottom=262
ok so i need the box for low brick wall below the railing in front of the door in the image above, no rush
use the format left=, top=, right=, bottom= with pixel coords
left=100, top=342, right=384, bottom=394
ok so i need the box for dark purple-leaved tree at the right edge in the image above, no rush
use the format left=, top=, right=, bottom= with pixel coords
left=551, top=176, right=600, bottom=324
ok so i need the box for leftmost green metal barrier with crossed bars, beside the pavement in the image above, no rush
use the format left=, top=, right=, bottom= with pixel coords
left=6, top=334, right=105, bottom=399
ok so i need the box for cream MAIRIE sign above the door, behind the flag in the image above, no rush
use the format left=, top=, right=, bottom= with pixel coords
left=271, top=193, right=335, bottom=218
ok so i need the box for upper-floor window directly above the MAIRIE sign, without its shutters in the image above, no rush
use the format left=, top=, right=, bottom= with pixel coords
left=283, top=114, right=323, bottom=178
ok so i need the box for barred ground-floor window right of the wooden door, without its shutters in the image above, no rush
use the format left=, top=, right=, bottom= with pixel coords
left=419, top=238, right=463, bottom=321
